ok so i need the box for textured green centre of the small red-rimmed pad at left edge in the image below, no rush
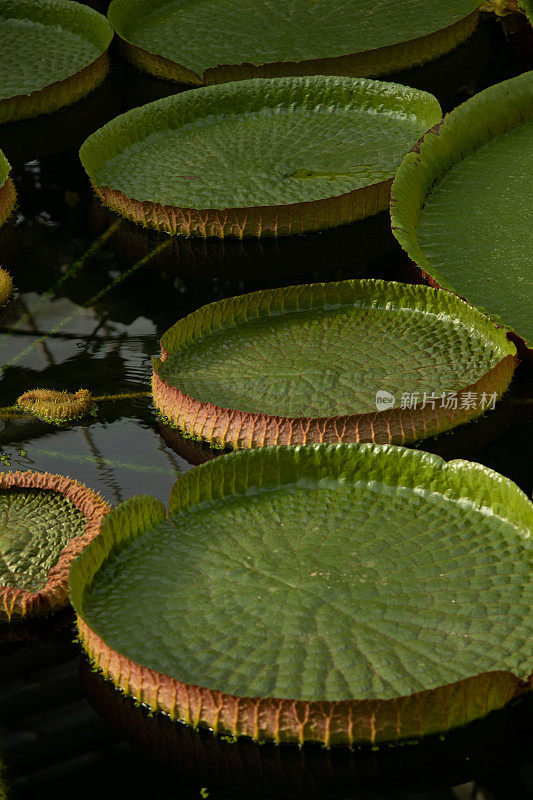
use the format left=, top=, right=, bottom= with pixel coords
left=0, top=487, right=86, bottom=592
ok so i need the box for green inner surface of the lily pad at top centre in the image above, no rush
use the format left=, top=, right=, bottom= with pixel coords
left=109, top=0, right=479, bottom=76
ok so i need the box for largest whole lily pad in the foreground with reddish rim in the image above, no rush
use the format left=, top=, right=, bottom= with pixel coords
left=70, top=445, right=533, bottom=745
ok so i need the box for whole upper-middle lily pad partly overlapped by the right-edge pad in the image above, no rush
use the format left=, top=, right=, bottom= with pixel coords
left=80, top=76, right=441, bottom=238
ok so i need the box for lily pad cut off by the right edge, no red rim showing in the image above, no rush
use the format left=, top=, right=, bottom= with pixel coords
left=391, top=72, right=533, bottom=354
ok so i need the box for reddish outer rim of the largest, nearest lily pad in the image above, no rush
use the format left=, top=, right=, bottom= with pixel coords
left=77, top=615, right=533, bottom=747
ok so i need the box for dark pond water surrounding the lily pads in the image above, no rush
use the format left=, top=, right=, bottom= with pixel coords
left=0, top=14, right=533, bottom=800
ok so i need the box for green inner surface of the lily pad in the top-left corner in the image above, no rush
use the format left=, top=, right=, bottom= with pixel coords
left=0, top=0, right=113, bottom=100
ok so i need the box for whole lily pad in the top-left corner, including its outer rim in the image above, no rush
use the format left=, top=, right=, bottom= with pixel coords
left=0, top=0, right=113, bottom=122
